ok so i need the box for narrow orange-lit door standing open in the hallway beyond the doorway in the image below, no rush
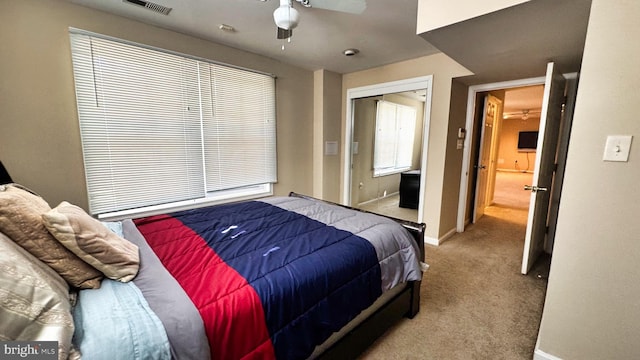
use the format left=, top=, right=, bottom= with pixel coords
left=473, top=95, right=502, bottom=223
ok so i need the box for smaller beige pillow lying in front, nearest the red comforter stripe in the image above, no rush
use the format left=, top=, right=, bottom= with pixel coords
left=42, top=201, right=140, bottom=282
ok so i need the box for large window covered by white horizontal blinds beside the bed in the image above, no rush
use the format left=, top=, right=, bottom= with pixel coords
left=71, top=31, right=276, bottom=215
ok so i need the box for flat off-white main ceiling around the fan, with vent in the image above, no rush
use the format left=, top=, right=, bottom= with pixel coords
left=66, top=0, right=439, bottom=74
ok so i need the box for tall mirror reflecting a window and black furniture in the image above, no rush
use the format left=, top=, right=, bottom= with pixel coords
left=351, top=91, right=426, bottom=221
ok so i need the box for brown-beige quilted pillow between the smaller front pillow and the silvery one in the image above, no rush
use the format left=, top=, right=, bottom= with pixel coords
left=0, top=184, right=102, bottom=289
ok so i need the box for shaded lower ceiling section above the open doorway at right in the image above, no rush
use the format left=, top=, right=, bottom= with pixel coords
left=421, top=0, right=591, bottom=85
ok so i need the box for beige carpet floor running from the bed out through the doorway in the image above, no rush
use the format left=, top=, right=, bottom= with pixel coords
left=361, top=172, right=550, bottom=360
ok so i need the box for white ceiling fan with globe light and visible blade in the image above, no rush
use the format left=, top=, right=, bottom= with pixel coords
left=273, top=0, right=367, bottom=39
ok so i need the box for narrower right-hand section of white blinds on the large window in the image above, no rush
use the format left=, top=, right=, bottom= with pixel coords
left=202, top=64, right=276, bottom=191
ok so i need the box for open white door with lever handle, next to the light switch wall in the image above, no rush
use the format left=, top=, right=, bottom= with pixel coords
left=522, top=63, right=565, bottom=274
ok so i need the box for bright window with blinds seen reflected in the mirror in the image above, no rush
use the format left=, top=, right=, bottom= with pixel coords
left=373, top=101, right=416, bottom=176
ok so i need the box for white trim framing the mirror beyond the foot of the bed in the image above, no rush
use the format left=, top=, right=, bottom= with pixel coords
left=342, top=75, right=433, bottom=222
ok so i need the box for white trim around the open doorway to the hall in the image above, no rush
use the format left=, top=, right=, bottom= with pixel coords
left=456, top=76, right=545, bottom=232
